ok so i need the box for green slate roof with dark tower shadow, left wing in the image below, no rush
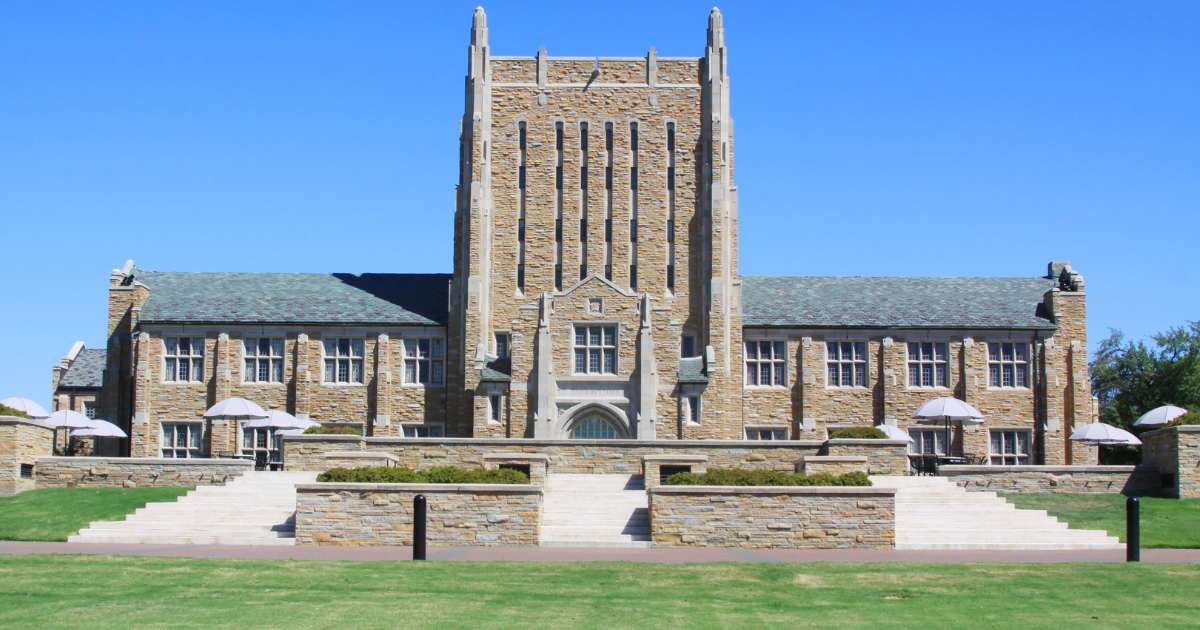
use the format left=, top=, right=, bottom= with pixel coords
left=133, top=270, right=450, bottom=325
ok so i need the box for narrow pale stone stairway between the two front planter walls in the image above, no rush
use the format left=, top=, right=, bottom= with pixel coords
left=541, top=473, right=650, bottom=547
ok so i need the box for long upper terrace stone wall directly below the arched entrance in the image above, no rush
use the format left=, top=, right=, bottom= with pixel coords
left=283, top=436, right=822, bottom=474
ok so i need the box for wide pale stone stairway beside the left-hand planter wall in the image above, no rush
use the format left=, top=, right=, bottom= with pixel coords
left=67, top=472, right=317, bottom=545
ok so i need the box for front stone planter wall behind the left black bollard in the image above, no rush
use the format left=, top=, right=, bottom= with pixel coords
left=295, top=484, right=542, bottom=546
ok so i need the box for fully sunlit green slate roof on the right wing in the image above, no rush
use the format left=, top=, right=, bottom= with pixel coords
left=742, top=276, right=1055, bottom=330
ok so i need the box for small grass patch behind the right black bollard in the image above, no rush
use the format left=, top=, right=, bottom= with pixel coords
left=1006, top=493, right=1200, bottom=548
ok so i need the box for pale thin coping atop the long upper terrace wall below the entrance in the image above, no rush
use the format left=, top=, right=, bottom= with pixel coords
left=283, top=434, right=825, bottom=449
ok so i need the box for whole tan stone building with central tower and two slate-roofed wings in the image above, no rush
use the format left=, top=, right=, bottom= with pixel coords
left=72, top=10, right=1094, bottom=464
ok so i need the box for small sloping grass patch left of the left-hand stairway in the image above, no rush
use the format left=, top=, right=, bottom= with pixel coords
left=0, top=487, right=191, bottom=541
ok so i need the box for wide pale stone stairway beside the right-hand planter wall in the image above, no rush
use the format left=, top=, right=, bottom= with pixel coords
left=871, top=476, right=1124, bottom=550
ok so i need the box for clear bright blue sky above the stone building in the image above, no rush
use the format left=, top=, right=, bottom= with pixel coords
left=0, top=0, right=1200, bottom=403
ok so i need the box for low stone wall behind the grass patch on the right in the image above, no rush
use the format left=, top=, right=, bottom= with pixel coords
left=937, top=466, right=1162, bottom=497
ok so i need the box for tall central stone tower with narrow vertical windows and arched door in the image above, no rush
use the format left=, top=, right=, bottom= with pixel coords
left=448, top=8, right=742, bottom=439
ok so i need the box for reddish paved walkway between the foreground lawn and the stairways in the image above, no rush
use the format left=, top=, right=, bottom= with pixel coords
left=0, top=542, right=1200, bottom=564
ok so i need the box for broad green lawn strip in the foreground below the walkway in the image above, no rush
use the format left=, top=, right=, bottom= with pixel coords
left=0, top=556, right=1200, bottom=630
